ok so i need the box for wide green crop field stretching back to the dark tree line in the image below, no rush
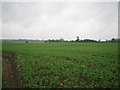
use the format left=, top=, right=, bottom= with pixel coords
left=2, top=42, right=118, bottom=88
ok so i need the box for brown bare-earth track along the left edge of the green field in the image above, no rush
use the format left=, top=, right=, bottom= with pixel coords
left=2, top=51, right=22, bottom=88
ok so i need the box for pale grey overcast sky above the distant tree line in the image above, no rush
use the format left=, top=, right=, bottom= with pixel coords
left=0, top=2, right=118, bottom=40
